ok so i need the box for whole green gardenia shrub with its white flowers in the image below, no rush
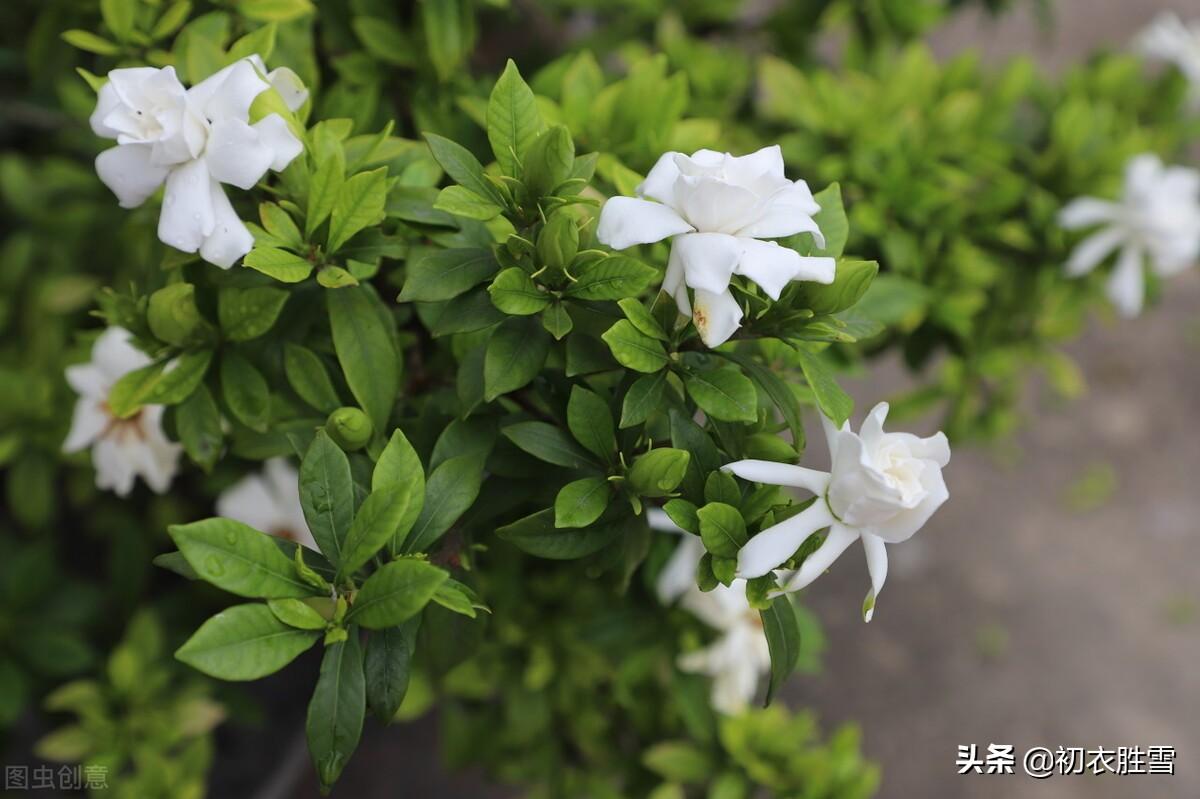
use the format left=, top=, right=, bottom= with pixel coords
left=0, top=0, right=1200, bottom=799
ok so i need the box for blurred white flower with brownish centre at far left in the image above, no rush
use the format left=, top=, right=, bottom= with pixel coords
left=62, top=328, right=182, bottom=497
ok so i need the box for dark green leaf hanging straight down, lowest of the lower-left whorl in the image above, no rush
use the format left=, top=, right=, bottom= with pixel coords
left=305, top=629, right=367, bottom=792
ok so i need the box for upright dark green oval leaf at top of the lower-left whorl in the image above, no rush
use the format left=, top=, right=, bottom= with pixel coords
left=300, top=429, right=354, bottom=566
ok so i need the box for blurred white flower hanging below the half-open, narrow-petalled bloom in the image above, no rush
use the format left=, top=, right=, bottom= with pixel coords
left=647, top=509, right=770, bottom=714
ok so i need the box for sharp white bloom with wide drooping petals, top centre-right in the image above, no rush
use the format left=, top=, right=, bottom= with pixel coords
left=596, top=144, right=834, bottom=347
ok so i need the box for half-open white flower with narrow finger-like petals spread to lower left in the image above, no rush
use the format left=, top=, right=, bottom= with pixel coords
left=722, top=402, right=950, bottom=621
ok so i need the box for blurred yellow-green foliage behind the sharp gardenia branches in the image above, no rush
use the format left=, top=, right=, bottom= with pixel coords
left=0, top=0, right=1196, bottom=799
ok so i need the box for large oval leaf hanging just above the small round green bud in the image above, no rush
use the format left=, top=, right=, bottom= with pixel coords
left=325, top=286, right=400, bottom=432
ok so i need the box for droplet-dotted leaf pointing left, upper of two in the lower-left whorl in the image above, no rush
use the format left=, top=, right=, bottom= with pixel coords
left=168, top=518, right=313, bottom=599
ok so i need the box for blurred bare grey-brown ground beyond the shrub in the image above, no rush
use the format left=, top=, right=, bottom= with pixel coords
left=283, top=0, right=1200, bottom=799
